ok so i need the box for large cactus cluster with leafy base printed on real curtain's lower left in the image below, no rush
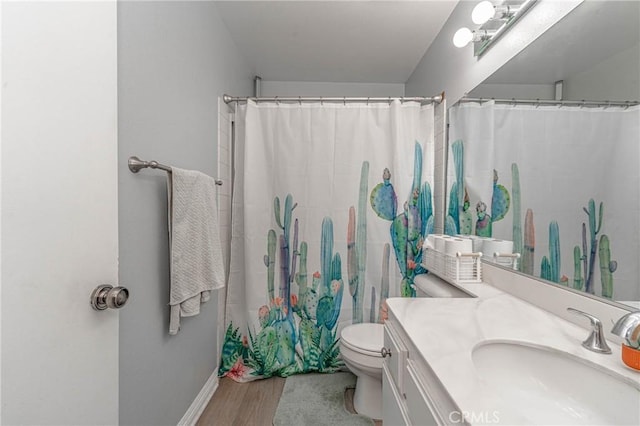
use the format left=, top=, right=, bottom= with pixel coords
left=219, top=194, right=344, bottom=381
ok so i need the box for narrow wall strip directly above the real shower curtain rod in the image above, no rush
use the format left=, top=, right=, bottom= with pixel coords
left=258, top=81, right=400, bottom=97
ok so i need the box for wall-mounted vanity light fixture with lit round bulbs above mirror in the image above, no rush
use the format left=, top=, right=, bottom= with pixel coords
left=453, top=0, right=537, bottom=56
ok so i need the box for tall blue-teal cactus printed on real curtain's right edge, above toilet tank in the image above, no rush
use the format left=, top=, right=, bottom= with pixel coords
left=370, top=142, right=433, bottom=297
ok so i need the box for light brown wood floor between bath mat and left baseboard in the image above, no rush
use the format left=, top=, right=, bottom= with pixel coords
left=197, top=377, right=286, bottom=426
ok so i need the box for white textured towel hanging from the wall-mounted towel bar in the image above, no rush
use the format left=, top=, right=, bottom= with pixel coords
left=167, top=167, right=225, bottom=334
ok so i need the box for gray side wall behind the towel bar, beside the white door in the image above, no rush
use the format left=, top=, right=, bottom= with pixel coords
left=119, top=2, right=253, bottom=425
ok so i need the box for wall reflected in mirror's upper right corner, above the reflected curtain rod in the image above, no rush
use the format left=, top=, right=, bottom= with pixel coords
left=564, top=44, right=640, bottom=101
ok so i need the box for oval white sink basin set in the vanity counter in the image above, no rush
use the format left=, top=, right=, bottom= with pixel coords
left=472, top=342, right=640, bottom=425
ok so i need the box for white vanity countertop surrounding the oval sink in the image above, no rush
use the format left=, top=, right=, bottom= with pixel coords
left=387, top=283, right=640, bottom=424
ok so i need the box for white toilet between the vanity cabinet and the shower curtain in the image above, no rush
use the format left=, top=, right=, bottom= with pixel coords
left=340, top=274, right=470, bottom=420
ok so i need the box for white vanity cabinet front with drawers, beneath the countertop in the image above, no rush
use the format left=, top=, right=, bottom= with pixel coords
left=382, top=314, right=464, bottom=426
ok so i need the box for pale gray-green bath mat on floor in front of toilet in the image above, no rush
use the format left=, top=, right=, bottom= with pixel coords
left=273, top=373, right=374, bottom=426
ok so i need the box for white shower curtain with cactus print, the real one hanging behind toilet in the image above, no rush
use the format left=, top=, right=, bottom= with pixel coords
left=219, top=100, right=433, bottom=381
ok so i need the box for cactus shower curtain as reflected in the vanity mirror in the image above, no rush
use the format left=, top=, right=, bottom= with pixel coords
left=447, top=101, right=640, bottom=301
